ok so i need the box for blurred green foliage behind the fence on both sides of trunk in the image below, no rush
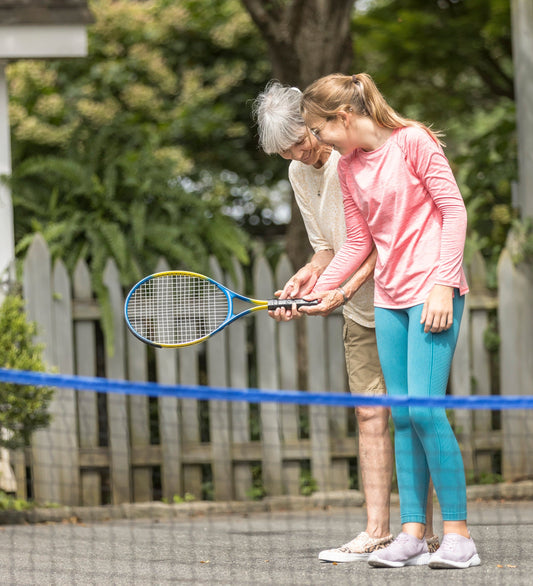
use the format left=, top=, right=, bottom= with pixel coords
left=8, top=0, right=517, bottom=298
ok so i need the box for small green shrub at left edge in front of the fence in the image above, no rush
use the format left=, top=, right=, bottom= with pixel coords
left=0, top=295, right=53, bottom=449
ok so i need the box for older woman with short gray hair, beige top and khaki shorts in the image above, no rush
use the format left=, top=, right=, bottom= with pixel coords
left=253, top=82, right=438, bottom=562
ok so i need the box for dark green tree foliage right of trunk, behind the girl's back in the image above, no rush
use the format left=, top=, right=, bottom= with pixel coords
left=353, top=0, right=517, bottom=266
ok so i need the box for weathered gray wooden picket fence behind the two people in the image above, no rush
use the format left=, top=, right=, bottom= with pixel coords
left=8, top=236, right=531, bottom=505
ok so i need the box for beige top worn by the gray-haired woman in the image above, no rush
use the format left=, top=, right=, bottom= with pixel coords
left=289, top=151, right=374, bottom=328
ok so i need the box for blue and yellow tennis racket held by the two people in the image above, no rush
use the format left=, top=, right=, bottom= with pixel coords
left=124, top=271, right=318, bottom=348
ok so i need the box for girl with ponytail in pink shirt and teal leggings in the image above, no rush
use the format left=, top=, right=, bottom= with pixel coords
left=302, top=73, right=480, bottom=568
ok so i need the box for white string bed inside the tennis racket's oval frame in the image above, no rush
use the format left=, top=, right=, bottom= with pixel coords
left=128, top=275, right=229, bottom=345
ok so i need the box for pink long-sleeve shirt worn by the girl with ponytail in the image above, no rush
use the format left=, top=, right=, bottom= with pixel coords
left=314, top=126, right=468, bottom=309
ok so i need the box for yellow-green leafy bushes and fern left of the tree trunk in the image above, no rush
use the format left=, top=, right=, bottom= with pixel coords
left=8, top=0, right=274, bottom=342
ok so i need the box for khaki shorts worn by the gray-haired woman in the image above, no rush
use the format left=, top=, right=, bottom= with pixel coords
left=343, top=318, right=387, bottom=395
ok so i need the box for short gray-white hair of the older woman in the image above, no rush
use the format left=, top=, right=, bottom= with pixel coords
left=252, top=81, right=305, bottom=155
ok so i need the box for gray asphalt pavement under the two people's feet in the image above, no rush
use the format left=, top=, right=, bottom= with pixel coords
left=0, top=486, right=533, bottom=586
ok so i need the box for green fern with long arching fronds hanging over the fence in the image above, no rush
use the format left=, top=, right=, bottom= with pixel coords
left=11, top=145, right=247, bottom=347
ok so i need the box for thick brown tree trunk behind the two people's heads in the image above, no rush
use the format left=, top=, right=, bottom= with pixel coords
left=242, top=0, right=354, bottom=268
